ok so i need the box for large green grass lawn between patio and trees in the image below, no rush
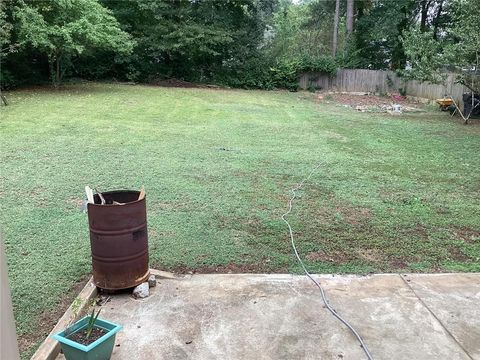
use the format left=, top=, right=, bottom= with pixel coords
left=0, top=84, right=480, bottom=357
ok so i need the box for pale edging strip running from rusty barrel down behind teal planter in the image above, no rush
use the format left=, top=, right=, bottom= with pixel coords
left=30, top=277, right=97, bottom=360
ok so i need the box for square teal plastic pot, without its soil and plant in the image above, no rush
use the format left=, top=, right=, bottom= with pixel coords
left=53, top=316, right=122, bottom=360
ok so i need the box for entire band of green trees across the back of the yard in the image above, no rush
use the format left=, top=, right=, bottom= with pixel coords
left=0, top=0, right=480, bottom=89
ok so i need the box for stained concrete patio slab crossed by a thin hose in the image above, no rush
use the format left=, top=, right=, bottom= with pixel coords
left=58, top=274, right=480, bottom=360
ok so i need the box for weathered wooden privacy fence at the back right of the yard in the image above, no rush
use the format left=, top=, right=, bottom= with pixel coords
left=299, top=69, right=469, bottom=107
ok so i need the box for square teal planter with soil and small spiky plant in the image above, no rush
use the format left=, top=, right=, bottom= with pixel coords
left=53, top=309, right=122, bottom=360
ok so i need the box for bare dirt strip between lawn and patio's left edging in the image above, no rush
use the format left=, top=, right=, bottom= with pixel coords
left=18, top=275, right=90, bottom=353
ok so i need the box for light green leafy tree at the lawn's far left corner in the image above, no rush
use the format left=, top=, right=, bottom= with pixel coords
left=14, top=0, right=134, bottom=85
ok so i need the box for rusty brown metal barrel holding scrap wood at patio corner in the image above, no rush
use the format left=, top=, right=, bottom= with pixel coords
left=88, top=190, right=149, bottom=290
